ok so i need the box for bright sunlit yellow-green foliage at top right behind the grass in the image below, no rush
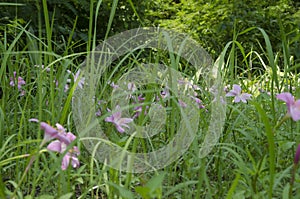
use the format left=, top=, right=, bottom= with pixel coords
left=147, top=0, right=300, bottom=59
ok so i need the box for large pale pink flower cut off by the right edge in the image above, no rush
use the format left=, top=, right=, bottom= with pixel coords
left=276, top=92, right=300, bottom=121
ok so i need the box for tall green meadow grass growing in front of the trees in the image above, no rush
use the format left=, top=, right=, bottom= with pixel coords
left=0, top=0, right=300, bottom=199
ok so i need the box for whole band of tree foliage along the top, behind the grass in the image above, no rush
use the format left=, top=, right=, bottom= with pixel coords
left=0, top=0, right=300, bottom=60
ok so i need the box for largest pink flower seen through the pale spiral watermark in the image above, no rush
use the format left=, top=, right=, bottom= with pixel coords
left=105, top=105, right=133, bottom=133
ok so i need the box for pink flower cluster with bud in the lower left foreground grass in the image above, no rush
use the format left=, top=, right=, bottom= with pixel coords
left=29, top=119, right=80, bottom=170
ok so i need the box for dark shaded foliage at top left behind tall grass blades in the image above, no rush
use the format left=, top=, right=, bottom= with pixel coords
left=0, top=0, right=145, bottom=52
